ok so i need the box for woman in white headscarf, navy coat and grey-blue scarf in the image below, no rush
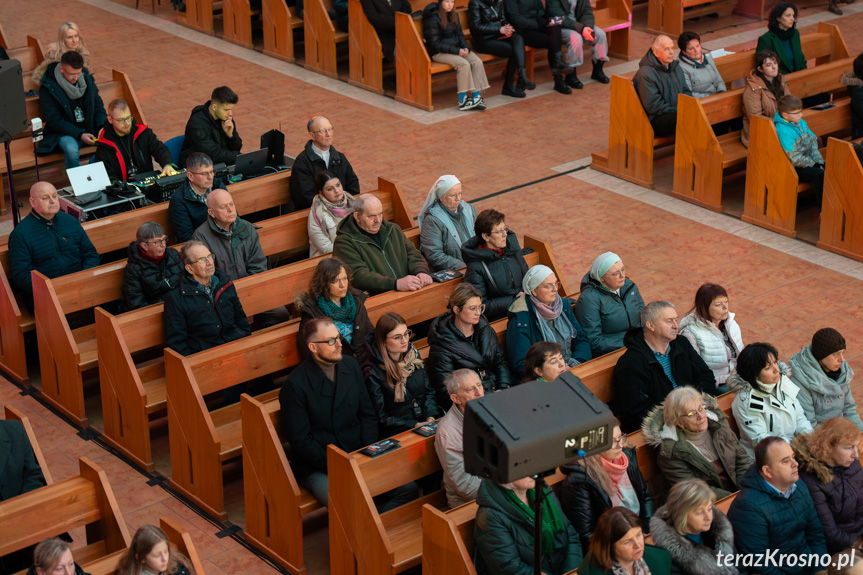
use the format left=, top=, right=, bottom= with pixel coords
left=506, top=265, right=592, bottom=374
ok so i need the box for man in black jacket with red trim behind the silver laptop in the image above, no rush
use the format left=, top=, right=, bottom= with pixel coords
left=96, top=100, right=177, bottom=182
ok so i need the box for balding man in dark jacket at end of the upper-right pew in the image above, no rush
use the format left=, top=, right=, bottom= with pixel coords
left=632, top=34, right=692, bottom=138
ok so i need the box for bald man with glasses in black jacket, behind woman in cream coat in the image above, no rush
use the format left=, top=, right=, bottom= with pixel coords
left=291, top=116, right=360, bottom=210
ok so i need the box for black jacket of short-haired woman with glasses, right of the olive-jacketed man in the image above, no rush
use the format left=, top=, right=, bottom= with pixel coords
left=461, top=231, right=527, bottom=321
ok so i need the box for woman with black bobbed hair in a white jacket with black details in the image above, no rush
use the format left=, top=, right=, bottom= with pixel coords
left=727, top=343, right=812, bottom=460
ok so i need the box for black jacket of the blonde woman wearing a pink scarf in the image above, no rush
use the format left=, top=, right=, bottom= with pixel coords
left=560, top=447, right=656, bottom=549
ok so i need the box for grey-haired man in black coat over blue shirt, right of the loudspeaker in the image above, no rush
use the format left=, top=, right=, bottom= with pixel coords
left=613, top=301, right=716, bottom=433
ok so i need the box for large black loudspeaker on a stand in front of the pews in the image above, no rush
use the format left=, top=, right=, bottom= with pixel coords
left=464, top=372, right=614, bottom=483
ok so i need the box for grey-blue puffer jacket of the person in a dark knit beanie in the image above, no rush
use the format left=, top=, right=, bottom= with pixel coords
left=788, top=345, right=863, bottom=431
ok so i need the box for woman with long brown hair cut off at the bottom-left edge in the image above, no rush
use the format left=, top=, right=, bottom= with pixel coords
left=114, top=525, right=195, bottom=575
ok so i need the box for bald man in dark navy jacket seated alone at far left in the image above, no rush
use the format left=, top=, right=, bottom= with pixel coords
left=9, top=182, right=99, bottom=310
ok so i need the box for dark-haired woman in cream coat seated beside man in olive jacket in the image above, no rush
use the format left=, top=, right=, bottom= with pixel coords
left=308, top=170, right=354, bottom=258
